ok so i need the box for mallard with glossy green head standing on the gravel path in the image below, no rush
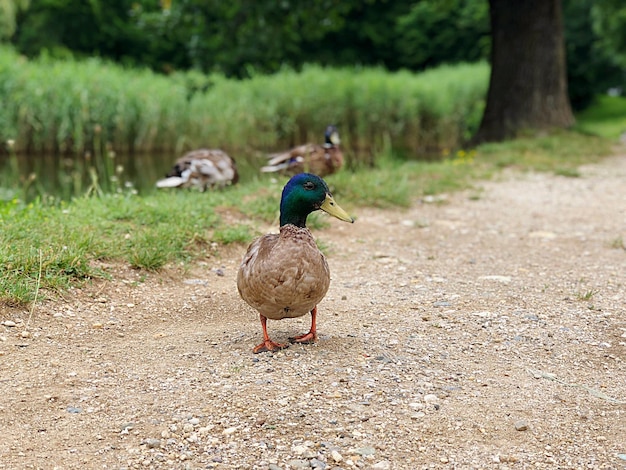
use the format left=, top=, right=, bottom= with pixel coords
left=237, top=173, right=354, bottom=353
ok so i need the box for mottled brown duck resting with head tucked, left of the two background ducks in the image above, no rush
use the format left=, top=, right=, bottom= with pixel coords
left=156, top=149, right=239, bottom=191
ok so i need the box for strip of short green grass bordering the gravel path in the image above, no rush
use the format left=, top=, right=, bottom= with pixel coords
left=0, top=126, right=612, bottom=305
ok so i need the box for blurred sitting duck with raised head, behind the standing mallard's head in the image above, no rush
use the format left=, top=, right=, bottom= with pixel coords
left=261, top=125, right=343, bottom=176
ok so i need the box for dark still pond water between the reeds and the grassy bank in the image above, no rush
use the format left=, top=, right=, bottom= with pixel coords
left=0, top=154, right=256, bottom=201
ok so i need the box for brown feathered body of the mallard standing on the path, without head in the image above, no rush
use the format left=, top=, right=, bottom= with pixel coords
left=237, top=224, right=330, bottom=320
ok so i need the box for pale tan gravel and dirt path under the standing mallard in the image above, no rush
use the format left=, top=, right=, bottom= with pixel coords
left=0, top=157, right=626, bottom=470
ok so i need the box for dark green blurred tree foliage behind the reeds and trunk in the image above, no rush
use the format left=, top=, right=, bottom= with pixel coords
left=0, top=0, right=626, bottom=109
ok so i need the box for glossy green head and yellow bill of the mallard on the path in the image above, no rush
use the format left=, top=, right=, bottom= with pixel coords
left=280, top=173, right=354, bottom=227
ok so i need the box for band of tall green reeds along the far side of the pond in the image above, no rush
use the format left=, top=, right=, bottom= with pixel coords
left=0, top=47, right=488, bottom=164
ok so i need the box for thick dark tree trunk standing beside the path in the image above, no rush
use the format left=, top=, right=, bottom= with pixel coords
left=474, top=0, right=574, bottom=142
